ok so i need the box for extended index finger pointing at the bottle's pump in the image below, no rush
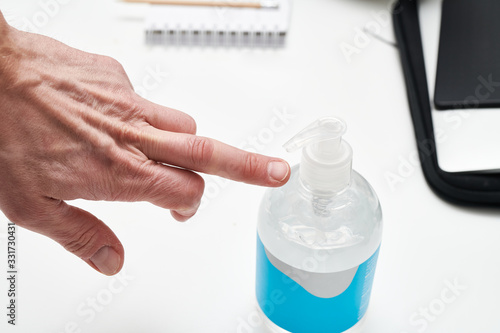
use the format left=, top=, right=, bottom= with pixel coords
left=141, top=129, right=290, bottom=187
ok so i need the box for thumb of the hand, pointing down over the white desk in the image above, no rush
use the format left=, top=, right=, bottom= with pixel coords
left=34, top=200, right=124, bottom=275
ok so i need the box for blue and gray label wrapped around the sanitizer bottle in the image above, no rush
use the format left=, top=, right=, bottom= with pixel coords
left=256, top=236, right=379, bottom=333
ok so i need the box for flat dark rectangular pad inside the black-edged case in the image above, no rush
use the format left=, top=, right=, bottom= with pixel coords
left=432, top=0, right=500, bottom=110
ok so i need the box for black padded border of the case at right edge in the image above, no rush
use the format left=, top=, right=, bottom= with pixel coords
left=392, top=0, right=500, bottom=208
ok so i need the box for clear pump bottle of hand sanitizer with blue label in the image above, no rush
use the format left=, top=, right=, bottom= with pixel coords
left=256, top=118, right=382, bottom=333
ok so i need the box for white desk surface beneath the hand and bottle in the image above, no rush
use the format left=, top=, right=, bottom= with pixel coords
left=0, top=0, right=500, bottom=333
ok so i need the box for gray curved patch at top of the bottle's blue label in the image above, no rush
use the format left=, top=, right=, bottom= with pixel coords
left=265, top=249, right=359, bottom=298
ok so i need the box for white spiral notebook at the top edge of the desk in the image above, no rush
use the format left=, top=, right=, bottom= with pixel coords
left=145, top=0, right=291, bottom=47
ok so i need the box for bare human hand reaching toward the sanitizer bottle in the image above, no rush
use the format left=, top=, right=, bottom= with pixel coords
left=0, top=13, right=290, bottom=275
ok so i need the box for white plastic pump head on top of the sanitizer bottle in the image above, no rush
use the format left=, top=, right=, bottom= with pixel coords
left=283, top=117, right=352, bottom=192
